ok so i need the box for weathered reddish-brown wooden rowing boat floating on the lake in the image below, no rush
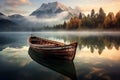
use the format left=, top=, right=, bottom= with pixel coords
left=28, top=35, right=77, bottom=60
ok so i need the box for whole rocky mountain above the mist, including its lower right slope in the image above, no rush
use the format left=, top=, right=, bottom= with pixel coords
left=30, top=2, right=80, bottom=18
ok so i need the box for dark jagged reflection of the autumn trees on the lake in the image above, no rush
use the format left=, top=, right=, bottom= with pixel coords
left=40, top=35, right=120, bottom=54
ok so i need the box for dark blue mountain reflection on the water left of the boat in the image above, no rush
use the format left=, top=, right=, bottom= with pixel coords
left=0, top=32, right=30, bottom=51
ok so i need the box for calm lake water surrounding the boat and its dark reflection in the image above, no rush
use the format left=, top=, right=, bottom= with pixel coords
left=0, top=32, right=120, bottom=80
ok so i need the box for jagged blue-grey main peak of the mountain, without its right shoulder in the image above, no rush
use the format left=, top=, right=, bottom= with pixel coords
left=31, top=2, right=68, bottom=17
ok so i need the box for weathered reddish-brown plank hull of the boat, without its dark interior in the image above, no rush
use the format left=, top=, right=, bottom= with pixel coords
left=28, top=37, right=77, bottom=60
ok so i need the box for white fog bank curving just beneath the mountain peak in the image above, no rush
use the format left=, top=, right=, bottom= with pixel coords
left=26, top=12, right=69, bottom=27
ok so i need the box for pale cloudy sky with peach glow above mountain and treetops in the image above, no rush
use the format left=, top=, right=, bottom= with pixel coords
left=0, top=0, right=120, bottom=16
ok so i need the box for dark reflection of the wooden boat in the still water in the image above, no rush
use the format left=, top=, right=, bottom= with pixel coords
left=28, top=48, right=77, bottom=80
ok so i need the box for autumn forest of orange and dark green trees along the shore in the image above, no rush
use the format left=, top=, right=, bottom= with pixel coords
left=44, top=8, right=120, bottom=30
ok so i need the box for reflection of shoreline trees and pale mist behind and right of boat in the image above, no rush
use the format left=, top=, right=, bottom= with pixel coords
left=34, top=33, right=120, bottom=54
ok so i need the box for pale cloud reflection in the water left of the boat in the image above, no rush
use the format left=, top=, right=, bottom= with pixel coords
left=0, top=46, right=31, bottom=66
